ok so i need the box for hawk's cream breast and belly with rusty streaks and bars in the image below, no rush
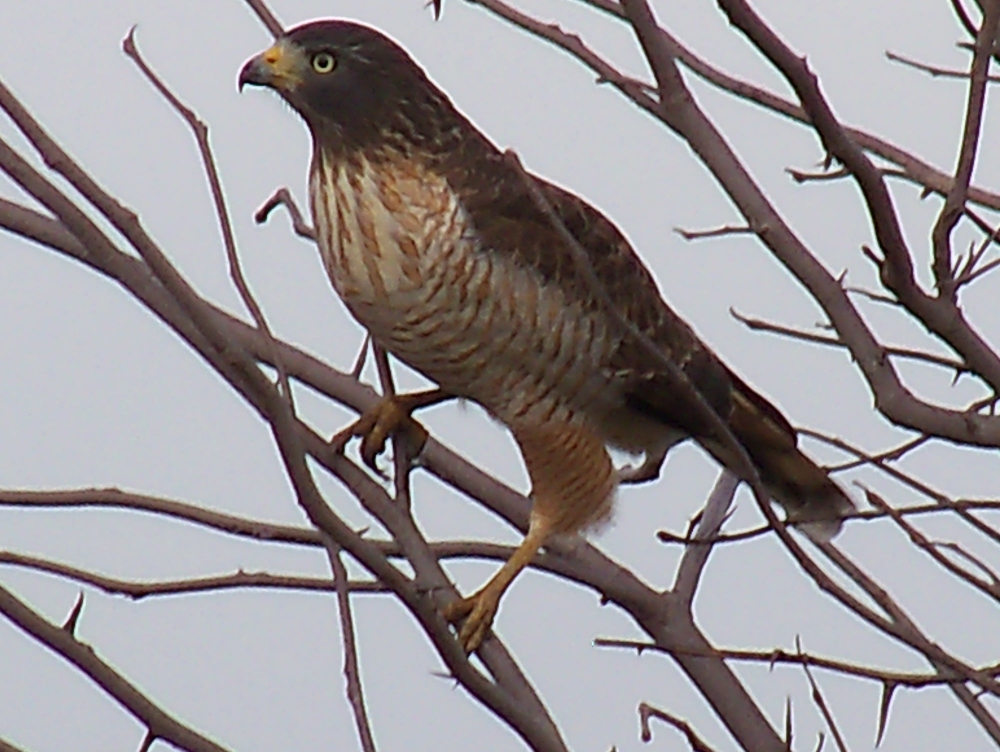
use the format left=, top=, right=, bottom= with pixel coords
left=310, top=153, right=613, bottom=427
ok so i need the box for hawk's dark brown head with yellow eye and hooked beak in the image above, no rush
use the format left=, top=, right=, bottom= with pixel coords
left=239, top=20, right=453, bottom=154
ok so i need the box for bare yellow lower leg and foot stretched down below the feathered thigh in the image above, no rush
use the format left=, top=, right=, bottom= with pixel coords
left=442, top=514, right=551, bottom=653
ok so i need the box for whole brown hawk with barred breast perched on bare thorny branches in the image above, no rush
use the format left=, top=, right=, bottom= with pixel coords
left=239, top=20, right=853, bottom=652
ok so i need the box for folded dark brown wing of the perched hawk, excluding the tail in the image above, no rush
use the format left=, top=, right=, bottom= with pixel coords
left=453, top=147, right=756, bottom=443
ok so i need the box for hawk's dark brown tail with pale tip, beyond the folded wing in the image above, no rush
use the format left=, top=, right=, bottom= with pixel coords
left=702, top=382, right=856, bottom=541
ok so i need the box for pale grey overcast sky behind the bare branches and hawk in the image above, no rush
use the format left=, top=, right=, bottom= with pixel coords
left=0, top=0, right=1000, bottom=752
